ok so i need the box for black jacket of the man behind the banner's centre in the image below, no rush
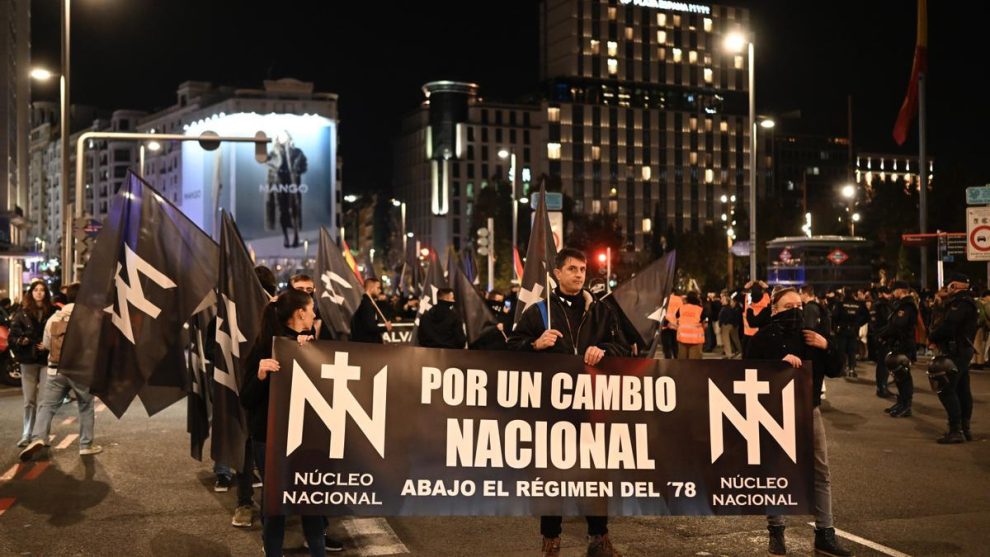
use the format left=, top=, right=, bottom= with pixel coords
left=508, top=290, right=630, bottom=356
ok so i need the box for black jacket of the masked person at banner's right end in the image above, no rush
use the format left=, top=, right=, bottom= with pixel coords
left=743, top=322, right=842, bottom=406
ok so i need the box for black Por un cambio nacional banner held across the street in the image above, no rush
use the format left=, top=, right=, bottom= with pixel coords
left=264, top=339, right=813, bottom=516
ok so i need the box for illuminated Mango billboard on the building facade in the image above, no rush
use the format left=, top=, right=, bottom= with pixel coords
left=179, top=113, right=337, bottom=257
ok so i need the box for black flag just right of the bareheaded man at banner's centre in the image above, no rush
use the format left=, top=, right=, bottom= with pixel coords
left=609, top=251, right=677, bottom=346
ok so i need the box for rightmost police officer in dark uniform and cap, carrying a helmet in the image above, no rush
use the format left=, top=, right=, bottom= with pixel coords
left=929, top=274, right=978, bottom=445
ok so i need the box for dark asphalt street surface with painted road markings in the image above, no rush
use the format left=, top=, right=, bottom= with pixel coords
left=0, top=356, right=990, bottom=557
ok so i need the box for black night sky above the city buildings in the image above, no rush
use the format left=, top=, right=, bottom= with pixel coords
left=32, top=0, right=990, bottom=200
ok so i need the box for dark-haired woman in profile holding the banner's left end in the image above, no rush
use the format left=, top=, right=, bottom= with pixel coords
left=241, top=289, right=343, bottom=557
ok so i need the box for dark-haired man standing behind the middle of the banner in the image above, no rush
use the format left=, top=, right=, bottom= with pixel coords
left=508, top=248, right=629, bottom=557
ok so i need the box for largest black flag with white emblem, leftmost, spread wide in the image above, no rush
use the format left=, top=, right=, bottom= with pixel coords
left=59, top=174, right=218, bottom=417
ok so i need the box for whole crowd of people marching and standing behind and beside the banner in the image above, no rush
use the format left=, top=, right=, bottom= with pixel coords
left=0, top=248, right=990, bottom=557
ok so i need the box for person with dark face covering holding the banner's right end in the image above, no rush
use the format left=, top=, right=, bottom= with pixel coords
left=744, top=288, right=852, bottom=557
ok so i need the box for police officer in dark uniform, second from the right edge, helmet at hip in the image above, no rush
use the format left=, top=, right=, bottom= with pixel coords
left=877, top=280, right=918, bottom=418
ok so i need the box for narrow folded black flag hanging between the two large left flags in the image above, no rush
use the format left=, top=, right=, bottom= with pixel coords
left=186, top=311, right=213, bottom=462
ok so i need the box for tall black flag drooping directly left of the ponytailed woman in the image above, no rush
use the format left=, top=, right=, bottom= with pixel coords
left=210, top=211, right=271, bottom=470
